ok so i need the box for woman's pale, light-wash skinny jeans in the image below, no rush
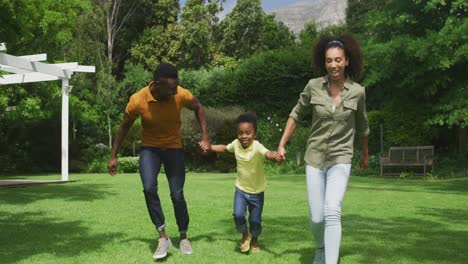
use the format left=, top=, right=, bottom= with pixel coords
left=306, top=164, right=351, bottom=264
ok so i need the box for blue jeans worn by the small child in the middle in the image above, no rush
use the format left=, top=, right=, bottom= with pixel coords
left=232, top=188, right=264, bottom=237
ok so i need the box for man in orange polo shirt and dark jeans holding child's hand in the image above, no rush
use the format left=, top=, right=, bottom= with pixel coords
left=108, top=63, right=209, bottom=259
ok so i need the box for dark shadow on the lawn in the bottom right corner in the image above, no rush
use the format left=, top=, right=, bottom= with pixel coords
left=342, top=212, right=468, bottom=263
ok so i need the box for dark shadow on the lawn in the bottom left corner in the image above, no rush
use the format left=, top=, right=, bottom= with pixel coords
left=0, top=212, right=123, bottom=263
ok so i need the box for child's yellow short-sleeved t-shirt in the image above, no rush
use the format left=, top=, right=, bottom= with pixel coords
left=226, top=139, right=268, bottom=194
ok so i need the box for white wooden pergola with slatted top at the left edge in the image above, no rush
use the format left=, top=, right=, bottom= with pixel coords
left=0, top=43, right=96, bottom=181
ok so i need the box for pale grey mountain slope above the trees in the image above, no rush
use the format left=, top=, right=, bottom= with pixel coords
left=268, top=0, right=348, bottom=35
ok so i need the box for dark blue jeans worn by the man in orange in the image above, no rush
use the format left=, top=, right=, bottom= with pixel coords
left=140, top=147, right=189, bottom=233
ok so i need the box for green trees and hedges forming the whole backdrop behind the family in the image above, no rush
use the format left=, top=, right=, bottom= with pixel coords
left=0, top=0, right=468, bottom=175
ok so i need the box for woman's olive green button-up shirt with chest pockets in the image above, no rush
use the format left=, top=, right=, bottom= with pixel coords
left=289, top=76, right=369, bottom=168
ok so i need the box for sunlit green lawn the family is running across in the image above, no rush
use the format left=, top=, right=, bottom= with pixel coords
left=0, top=174, right=468, bottom=264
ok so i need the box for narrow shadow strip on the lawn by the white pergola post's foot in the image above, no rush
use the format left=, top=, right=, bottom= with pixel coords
left=0, top=182, right=114, bottom=204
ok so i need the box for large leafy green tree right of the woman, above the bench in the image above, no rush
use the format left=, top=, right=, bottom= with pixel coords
left=348, top=0, right=468, bottom=153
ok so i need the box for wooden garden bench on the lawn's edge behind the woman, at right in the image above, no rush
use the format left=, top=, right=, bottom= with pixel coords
left=380, top=146, right=434, bottom=176
